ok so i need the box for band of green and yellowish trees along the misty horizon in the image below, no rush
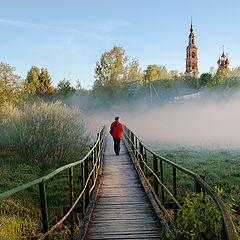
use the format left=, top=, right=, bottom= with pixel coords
left=0, top=46, right=240, bottom=109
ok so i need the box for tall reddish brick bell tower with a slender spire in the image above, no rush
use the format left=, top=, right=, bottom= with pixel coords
left=186, top=19, right=198, bottom=74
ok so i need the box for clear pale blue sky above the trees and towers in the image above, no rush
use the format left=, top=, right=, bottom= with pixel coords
left=0, top=0, right=240, bottom=88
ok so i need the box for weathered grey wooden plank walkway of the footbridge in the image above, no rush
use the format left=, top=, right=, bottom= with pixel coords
left=86, top=134, right=162, bottom=240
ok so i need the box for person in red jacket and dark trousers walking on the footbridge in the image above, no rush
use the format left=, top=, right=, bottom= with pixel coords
left=110, top=116, right=124, bottom=155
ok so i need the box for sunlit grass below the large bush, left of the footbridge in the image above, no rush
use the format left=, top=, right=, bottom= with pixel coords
left=0, top=155, right=89, bottom=240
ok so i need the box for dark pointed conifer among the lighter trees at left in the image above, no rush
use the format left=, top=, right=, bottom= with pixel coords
left=36, top=68, right=54, bottom=96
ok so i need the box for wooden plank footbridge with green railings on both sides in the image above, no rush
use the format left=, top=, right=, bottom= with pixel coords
left=0, top=126, right=238, bottom=240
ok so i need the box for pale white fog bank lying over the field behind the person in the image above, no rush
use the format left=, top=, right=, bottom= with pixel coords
left=90, top=97, right=240, bottom=148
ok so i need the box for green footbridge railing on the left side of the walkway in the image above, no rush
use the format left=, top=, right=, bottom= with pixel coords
left=0, top=127, right=105, bottom=240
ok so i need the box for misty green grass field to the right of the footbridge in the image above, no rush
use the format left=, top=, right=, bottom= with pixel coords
left=147, top=142, right=240, bottom=214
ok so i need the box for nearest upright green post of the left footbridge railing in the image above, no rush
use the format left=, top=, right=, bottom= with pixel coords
left=39, top=180, right=50, bottom=240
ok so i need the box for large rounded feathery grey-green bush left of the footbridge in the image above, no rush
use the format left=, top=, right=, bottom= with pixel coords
left=3, top=102, right=89, bottom=167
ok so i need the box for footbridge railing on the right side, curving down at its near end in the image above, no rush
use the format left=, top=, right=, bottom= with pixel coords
left=124, top=125, right=239, bottom=240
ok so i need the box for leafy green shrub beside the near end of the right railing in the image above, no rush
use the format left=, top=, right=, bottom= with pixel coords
left=172, top=188, right=237, bottom=240
